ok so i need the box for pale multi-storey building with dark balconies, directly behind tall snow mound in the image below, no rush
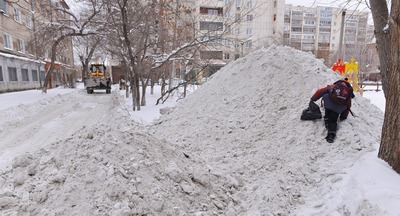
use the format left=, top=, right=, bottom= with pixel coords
left=194, top=0, right=285, bottom=73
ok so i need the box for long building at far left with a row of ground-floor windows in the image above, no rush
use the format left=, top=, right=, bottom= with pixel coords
left=0, top=0, right=73, bottom=92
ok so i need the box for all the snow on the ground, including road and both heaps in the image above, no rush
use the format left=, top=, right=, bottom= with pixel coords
left=0, top=47, right=400, bottom=216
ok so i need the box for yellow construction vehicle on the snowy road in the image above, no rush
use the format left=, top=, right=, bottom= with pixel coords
left=84, top=64, right=111, bottom=94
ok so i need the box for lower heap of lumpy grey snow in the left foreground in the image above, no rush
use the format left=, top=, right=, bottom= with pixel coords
left=0, top=115, right=239, bottom=215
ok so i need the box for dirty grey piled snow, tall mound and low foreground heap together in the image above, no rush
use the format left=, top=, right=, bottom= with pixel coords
left=0, top=47, right=383, bottom=216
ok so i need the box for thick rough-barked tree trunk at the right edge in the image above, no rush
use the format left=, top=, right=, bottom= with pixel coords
left=369, top=0, right=400, bottom=173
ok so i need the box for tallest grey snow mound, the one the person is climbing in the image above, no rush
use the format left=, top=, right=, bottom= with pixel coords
left=151, top=47, right=382, bottom=215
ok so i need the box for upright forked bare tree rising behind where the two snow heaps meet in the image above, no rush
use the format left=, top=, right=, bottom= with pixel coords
left=103, top=0, right=152, bottom=111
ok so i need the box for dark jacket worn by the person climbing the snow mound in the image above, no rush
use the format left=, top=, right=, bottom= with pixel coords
left=311, top=80, right=354, bottom=115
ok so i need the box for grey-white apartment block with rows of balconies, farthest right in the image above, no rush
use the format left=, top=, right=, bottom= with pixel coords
left=284, top=5, right=371, bottom=65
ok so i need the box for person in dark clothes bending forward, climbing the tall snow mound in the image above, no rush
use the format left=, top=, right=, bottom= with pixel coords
left=311, top=78, right=355, bottom=143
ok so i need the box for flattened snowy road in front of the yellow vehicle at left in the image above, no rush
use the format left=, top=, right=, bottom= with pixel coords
left=0, top=89, right=117, bottom=169
